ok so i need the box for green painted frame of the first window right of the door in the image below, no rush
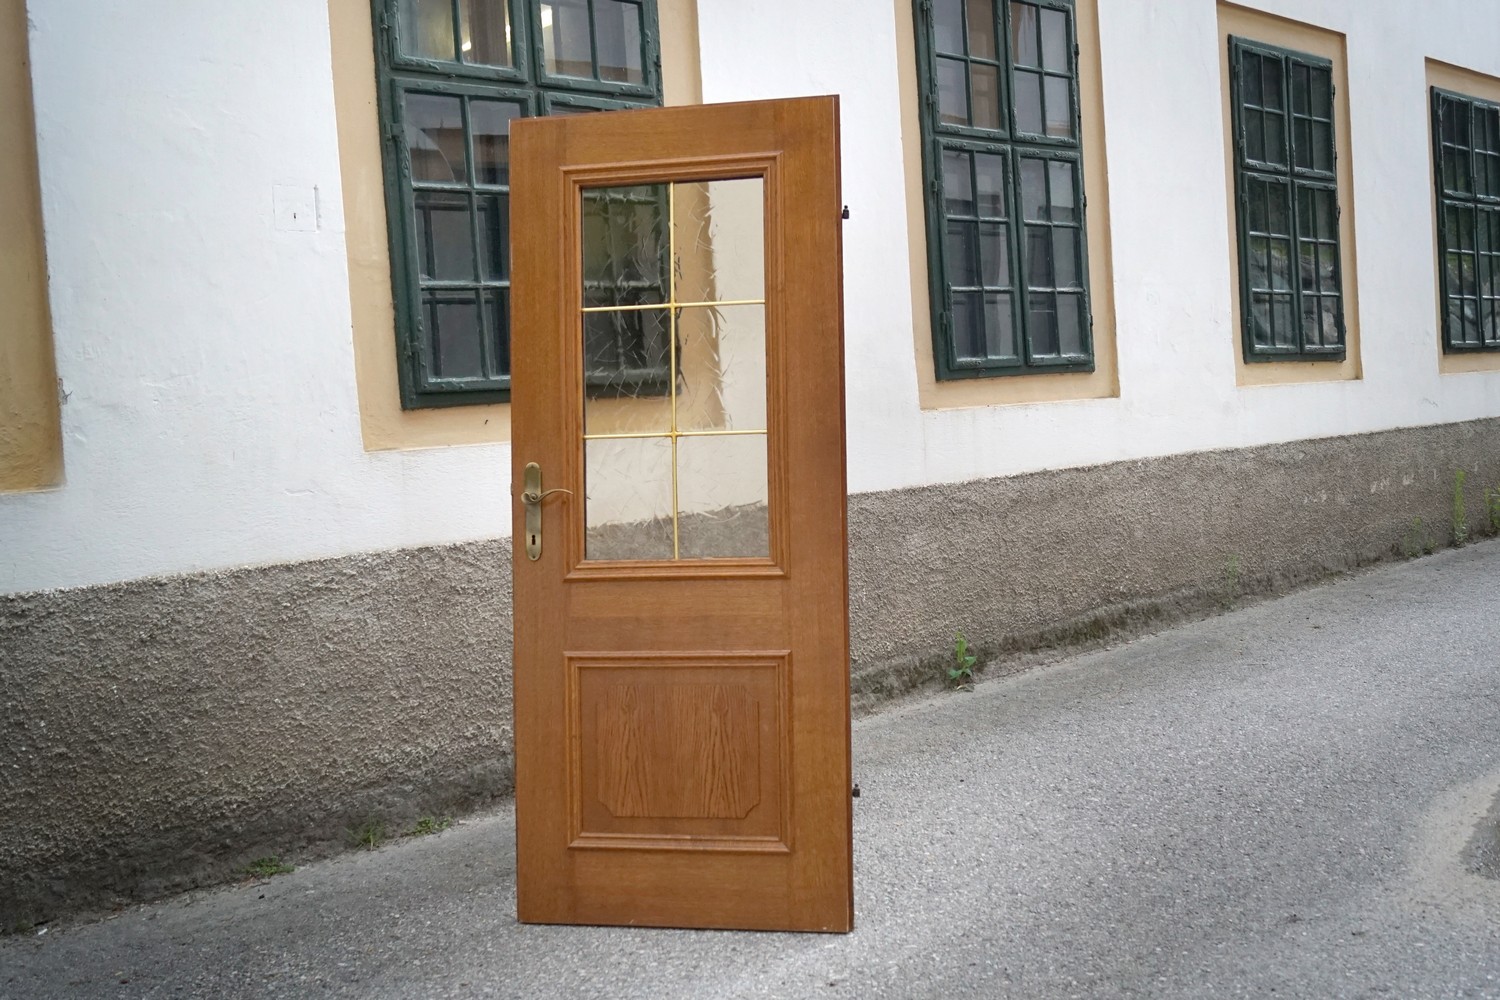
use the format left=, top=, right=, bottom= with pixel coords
left=912, top=0, right=1094, bottom=381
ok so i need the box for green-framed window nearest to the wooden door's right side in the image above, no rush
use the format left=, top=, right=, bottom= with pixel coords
left=915, top=0, right=1094, bottom=379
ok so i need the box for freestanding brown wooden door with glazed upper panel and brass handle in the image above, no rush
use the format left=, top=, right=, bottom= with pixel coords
left=510, top=97, right=854, bottom=931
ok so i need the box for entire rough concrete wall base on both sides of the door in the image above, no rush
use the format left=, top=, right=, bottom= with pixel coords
left=0, top=420, right=1500, bottom=928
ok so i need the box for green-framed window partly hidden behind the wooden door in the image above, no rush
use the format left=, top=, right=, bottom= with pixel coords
left=374, top=0, right=662, bottom=409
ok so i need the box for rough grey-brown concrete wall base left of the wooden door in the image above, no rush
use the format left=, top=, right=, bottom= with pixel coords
left=0, top=540, right=512, bottom=930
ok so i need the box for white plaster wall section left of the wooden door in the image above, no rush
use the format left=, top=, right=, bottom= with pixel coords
left=0, top=0, right=510, bottom=592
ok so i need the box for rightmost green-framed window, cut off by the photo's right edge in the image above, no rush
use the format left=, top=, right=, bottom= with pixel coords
left=1433, top=87, right=1500, bottom=352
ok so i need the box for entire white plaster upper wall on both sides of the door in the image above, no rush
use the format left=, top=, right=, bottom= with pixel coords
left=0, top=0, right=1500, bottom=592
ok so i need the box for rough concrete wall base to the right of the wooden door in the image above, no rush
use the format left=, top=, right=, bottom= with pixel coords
left=849, top=420, right=1500, bottom=705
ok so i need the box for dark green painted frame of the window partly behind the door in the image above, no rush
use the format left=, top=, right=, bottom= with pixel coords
left=371, top=0, right=662, bottom=409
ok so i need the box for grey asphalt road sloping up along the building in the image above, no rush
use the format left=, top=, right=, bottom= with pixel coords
left=0, top=543, right=1500, bottom=1000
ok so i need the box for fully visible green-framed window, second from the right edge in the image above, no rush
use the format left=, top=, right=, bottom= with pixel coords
left=1230, top=37, right=1344, bottom=361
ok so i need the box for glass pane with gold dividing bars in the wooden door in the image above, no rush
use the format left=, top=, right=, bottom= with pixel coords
left=581, top=178, right=770, bottom=559
